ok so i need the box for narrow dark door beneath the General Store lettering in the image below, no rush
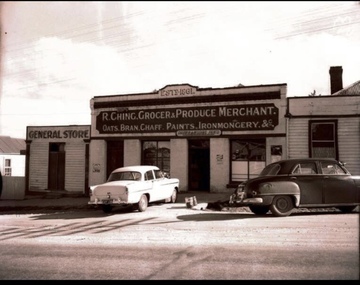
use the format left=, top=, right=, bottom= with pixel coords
left=48, top=143, right=65, bottom=190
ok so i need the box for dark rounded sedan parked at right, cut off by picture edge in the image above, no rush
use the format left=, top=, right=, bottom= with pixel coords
left=229, top=158, right=360, bottom=217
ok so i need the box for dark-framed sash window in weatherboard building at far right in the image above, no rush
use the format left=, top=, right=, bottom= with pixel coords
left=309, top=121, right=337, bottom=159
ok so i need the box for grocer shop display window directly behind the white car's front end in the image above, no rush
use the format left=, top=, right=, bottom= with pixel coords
left=142, top=141, right=170, bottom=173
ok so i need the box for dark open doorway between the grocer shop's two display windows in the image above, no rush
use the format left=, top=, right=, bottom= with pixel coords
left=188, top=140, right=210, bottom=192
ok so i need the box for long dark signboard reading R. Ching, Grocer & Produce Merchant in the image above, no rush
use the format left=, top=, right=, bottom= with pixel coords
left=96, top=104, right=279, bottom=136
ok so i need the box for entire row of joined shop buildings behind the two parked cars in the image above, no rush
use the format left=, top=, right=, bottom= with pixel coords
left=21, top=67, right=360, bottom=194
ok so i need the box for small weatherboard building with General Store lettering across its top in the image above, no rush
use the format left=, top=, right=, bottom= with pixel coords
left=26, top=125, right=90, bottom=194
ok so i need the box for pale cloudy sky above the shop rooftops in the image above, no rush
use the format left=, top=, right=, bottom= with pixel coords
left=0, top=1, right=360, bottom=139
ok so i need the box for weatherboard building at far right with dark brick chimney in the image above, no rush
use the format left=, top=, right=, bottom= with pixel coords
left=286, top=66, right=360, bottom=175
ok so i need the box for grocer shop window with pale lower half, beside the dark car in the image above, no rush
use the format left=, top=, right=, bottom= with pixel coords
left=231, top=139, right=266, bottom=182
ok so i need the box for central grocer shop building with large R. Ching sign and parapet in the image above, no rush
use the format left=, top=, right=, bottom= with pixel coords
left=89, top=84, right=287, bottom=192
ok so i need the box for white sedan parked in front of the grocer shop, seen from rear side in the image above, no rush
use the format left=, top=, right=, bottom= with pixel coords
left=88, top=165, right=179, bottom=213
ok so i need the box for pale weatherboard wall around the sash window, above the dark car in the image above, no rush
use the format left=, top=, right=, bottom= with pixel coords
left=288, top=95, right=360, bottom=175
